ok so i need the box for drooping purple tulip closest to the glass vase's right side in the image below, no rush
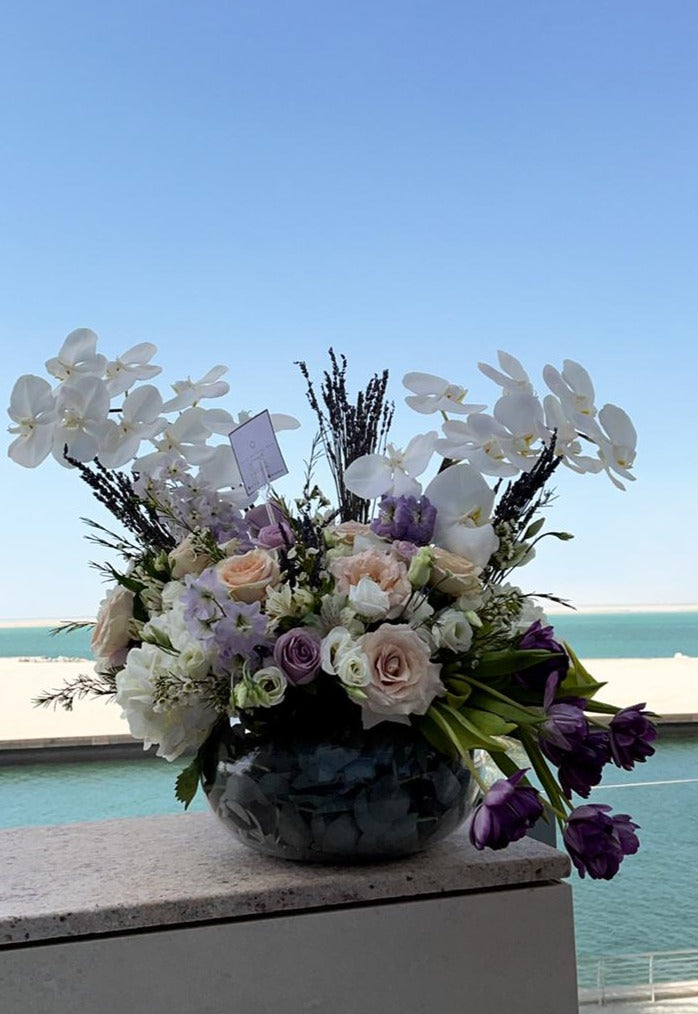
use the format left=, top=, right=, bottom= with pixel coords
left=470, top=769, right=543, bottom=849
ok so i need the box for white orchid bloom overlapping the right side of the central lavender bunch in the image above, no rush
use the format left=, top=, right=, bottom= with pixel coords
left=344, top=430, right=438, bottom=500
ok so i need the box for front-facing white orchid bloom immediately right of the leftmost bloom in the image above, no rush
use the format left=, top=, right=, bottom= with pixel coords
left=53, top=375, right=110, bottom=467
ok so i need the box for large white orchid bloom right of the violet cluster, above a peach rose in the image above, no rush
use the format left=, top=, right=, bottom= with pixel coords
left=424, top=464, right=499, bottom=567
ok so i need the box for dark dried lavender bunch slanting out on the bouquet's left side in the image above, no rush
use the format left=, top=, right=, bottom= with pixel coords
left=63, top=446, right=177, bottom=553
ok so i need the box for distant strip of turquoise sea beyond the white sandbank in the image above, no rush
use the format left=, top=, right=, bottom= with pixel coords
left=0, top=611, right=698, bottom=658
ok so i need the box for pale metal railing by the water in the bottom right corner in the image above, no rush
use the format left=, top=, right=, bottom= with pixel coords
left=577, top=950, right=698, bottom=1007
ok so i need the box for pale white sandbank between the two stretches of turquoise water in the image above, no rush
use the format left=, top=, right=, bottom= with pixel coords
left=0, top=656, right=698, bottom=742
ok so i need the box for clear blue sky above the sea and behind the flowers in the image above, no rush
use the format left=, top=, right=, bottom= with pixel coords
left=0, top=0, right=698, bottom=618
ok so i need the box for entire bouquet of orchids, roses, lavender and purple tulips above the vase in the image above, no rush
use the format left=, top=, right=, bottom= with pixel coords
left=9, top=330, right=656, bottom=879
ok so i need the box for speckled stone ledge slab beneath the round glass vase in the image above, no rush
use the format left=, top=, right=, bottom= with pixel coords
left=0, top=813, right=569, bottom=946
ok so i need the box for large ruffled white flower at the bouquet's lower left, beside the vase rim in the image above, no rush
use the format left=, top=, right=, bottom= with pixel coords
left=116, top=644, right=217, bottom=761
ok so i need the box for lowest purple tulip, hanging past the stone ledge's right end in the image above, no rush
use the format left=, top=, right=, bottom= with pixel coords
left=562, top=803, right=640, bottom=880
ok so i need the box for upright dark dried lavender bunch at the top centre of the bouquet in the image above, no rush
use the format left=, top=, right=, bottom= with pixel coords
left=296, top=349, right=395, bottom=523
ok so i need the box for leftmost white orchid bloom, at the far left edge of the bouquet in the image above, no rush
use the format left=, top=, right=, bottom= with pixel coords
left=7, top=374, right=56, bottom=468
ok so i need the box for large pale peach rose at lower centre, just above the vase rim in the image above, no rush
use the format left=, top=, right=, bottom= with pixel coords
left=358, top=624, right=445, bottom=717
